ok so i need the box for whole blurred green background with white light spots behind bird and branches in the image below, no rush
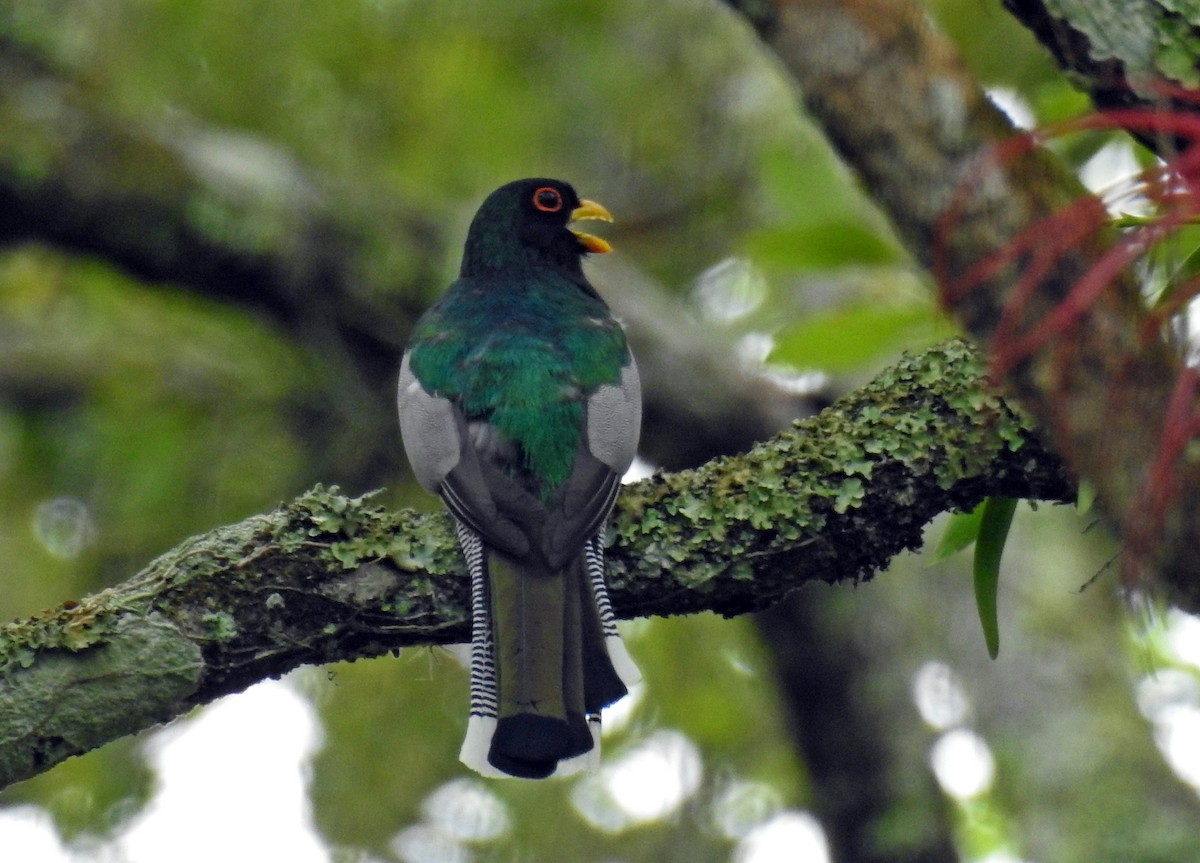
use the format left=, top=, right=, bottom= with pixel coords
left=0, top=0, right=1200, bottom=863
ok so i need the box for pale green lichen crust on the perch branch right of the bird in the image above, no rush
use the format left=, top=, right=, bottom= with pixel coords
left=616, top=340, right=1026, bottom=588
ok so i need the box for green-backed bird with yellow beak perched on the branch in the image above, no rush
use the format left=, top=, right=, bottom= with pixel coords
left=397, top=178, right=642, bottom=779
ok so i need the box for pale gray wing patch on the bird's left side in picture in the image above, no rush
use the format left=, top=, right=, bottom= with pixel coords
left=396, top=352, right=462, bottom=495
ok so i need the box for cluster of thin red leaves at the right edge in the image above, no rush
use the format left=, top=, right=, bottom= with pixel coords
left=934, top=88, right=1200, bottom=583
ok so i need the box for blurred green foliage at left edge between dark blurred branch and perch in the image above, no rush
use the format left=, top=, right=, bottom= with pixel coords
left=0, top=248, right=308, bottom=617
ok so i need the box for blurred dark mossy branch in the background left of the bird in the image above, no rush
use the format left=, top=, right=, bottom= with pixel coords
left=0, top=37, right=442, bottom=357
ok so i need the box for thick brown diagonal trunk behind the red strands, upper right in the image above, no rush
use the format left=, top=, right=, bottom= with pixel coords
left=732, top=0, right=1200, bottom=607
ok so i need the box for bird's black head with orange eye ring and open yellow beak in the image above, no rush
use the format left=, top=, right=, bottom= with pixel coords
left=462, top=178, right=612, bottom=276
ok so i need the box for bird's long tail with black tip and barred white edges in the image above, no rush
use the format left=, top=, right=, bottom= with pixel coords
left=458, top=526, right=640, bottom=779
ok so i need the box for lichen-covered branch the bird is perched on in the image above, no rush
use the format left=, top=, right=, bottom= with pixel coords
left=0, top=342, right=1073, bottom=786
